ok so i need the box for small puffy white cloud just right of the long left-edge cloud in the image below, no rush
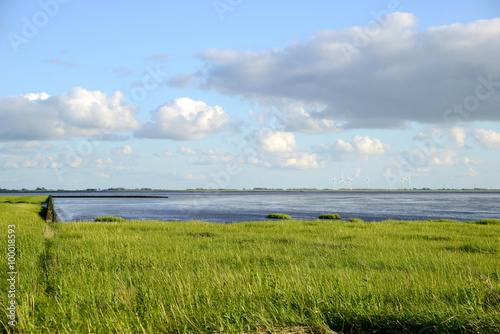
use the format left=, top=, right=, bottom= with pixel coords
left=135, top=97, right=230, bottom=140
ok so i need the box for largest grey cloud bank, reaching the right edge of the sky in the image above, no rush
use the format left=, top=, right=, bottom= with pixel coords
left=197, top=13, right=500, bottom=132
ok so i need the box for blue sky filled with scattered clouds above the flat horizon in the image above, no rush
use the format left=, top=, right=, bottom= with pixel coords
left=0, top=0, right=500, bottom=190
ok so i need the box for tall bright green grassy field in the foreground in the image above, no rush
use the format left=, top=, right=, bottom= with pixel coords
left=0, top=197, right=500, bottom=333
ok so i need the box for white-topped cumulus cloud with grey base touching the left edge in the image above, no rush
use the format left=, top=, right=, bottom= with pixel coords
left=0, top=87, right=140, bottom=140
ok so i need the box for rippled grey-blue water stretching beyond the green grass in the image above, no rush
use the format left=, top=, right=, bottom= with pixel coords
left=47, top=191, right=500, bottom=223
